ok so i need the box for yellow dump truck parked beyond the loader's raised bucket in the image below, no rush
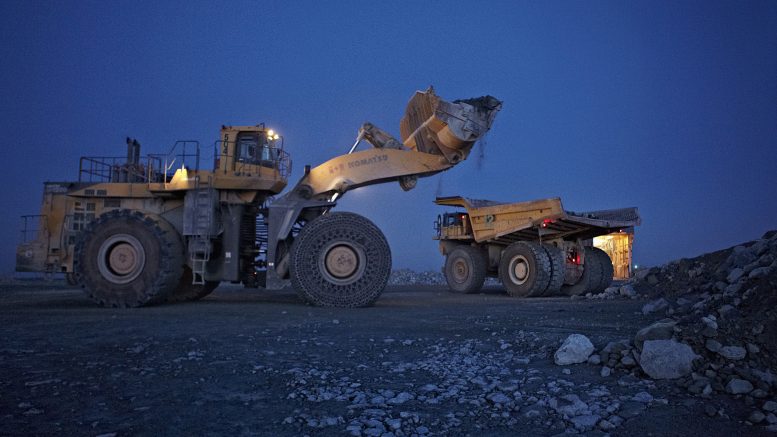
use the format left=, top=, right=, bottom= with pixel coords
left=435, top=196, right=640, bottom=297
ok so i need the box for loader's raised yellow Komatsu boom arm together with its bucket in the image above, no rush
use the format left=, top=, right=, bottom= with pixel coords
left=267, top=88, right=502, bottom=288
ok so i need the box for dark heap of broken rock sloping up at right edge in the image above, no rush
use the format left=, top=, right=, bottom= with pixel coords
left=634, top=231, right=777, bottom=431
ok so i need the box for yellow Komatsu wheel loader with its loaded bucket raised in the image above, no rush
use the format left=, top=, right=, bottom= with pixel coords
left=16, top=88, right=501, bottom=307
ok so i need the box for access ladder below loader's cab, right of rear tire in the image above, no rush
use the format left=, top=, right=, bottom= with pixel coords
left=185, top=177, right=216, bottom=285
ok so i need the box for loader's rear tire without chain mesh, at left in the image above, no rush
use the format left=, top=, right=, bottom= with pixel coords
left=73, top=210, right=184, bottom=307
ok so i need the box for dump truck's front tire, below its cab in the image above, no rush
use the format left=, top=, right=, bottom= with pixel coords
left=445, top=246, right=487, bottom=293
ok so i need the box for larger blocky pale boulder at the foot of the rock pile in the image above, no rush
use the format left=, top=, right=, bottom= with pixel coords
left=639, top=340, right=698, bottom=379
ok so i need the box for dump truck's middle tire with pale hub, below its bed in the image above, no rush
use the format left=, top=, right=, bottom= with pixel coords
left=499, top=241, right=551, bottom=297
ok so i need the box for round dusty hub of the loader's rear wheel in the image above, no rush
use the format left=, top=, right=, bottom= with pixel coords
left=97, top=234, right=146, bottom=284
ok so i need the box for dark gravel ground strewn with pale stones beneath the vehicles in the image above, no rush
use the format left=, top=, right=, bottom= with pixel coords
left=0, top=281, right=777, bottom=436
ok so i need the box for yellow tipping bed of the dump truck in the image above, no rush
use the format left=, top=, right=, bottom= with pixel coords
left=435, top=196, right=641, bottom=245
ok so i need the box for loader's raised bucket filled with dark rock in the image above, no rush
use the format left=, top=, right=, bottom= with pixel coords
left=399, top=87, right=502, bottom=164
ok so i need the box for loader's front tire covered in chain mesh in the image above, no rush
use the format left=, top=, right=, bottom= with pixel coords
left=289, top=212, right=391, bottom=307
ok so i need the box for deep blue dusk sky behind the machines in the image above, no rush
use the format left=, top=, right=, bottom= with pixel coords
left=0, top=0, right=777, bottom=273
